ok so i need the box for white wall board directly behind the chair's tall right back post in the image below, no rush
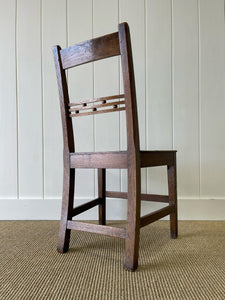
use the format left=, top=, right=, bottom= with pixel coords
left=119, top=0, right=146, bottom=192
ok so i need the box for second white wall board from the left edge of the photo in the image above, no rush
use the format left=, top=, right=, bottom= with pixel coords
left=17, top=0, right=43, bottom=198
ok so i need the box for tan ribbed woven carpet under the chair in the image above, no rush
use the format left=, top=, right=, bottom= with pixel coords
left=0, top=221, right=225, bottom=300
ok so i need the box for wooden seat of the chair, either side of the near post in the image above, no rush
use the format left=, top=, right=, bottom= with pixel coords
left=70, top=150, right=176, bottom=169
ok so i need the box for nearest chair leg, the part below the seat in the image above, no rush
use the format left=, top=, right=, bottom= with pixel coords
left=124, top=168, right=141, bottom=271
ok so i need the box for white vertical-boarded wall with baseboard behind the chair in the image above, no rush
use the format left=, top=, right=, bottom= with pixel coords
left=0, top=0, right=225, bottom=220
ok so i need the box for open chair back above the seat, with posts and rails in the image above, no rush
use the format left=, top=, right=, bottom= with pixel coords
left=53, top=23, right=140, bottom=154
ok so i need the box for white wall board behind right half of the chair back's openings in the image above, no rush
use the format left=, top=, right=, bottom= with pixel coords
left=93, top=0, right=120, bottom=190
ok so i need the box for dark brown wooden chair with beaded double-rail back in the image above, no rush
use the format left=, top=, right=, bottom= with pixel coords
left=53, top=23, right=177, bottom=271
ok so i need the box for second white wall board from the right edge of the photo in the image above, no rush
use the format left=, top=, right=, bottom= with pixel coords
left=173, top=0, right=200, bottom=197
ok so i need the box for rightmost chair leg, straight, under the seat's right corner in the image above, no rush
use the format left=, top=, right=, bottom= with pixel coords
left=167, top=160, right=178, bottom=239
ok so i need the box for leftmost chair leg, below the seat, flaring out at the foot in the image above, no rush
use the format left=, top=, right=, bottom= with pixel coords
left=57, top=168, right=75, bottom=253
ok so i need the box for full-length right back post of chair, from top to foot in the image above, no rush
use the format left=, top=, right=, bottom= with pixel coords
left=119, top=23, right=141, bottom=271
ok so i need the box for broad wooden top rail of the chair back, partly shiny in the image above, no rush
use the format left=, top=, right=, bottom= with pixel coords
left=60, top=32, right=120, bottom=70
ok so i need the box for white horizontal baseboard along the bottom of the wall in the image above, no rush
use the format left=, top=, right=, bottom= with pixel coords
left=0, top=197, right=225, bottom=220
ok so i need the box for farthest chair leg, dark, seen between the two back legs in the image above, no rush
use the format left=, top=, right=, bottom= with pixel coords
left=98, top=169, right=106, bottom=225
